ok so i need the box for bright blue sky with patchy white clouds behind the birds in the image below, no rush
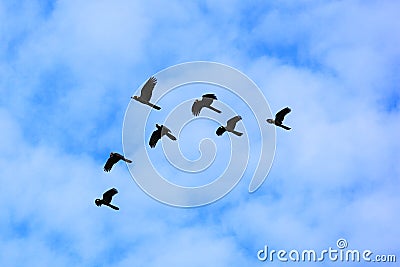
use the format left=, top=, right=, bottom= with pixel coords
left=0, top=0, right=400, bottom=267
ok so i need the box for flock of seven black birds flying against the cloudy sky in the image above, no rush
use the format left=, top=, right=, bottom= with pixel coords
left=95, top=77, right=291, bottom=210
